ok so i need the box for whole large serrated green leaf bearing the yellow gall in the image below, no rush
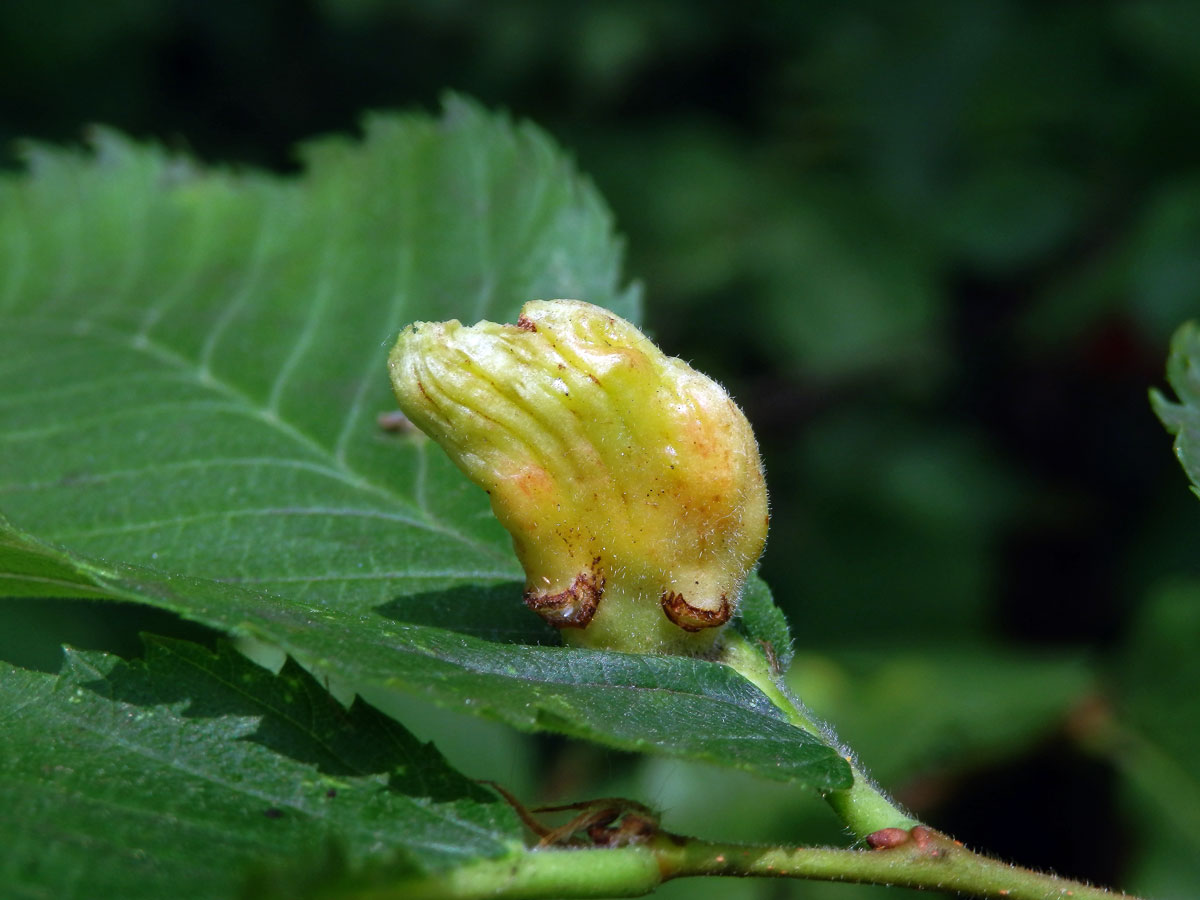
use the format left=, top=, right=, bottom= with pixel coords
left=0, top=101, right=848, bottom=788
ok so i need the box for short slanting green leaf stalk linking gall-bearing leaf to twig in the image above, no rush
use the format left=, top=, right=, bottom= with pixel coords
left=721, top=632, right=920, bottom=839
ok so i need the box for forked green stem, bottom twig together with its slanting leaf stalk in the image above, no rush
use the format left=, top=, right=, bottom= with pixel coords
left=350, top=635, right=1136, bottom=900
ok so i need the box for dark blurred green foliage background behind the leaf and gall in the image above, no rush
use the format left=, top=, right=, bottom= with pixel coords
left=0, top=0, right=1200, bottom=898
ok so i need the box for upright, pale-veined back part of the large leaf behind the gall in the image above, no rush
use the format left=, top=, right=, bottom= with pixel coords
left=0, top=100, right=638, bottom=610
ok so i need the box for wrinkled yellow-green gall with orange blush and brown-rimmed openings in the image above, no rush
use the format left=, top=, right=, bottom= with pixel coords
left=388, top=300, right=767, bottom=653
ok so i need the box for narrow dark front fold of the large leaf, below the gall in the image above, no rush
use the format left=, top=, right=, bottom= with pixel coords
left=0, top=521, right=850, bottom=790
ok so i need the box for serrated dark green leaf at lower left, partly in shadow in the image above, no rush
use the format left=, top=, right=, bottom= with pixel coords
left=0, top=638, right=522, bottom=898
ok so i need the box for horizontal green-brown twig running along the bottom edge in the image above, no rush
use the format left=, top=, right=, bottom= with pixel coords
left=369, top=828, right=1135, bottom=900
